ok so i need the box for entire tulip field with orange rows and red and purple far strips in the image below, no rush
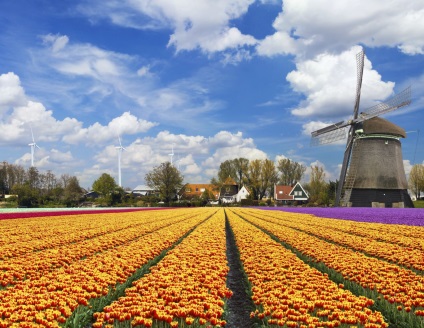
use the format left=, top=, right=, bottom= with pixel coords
left=0, top=207, right=424, bottom=328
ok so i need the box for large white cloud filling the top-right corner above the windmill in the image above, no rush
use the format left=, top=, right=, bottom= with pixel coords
left=258, top=0, right=424, bottom=57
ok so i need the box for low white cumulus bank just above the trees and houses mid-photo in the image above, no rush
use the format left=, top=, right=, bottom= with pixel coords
left=90, top=131, right=267, bottom=185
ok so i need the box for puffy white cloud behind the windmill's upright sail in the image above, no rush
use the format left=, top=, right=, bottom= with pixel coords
left=287, top=47, right=394, bottom=119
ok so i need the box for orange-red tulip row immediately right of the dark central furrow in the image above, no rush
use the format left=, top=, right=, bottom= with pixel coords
left=226, top=210, right=388, bottom=328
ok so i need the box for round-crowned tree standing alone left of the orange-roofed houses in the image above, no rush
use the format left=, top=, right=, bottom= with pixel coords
left=144, top=162, right=184, bottom=204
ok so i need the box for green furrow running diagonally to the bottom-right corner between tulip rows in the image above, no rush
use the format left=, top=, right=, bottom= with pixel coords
left=235, top=210, right=424, bottom=328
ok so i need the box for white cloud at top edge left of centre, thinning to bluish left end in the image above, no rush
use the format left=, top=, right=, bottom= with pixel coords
left=79, top=0, right=257, bottom=53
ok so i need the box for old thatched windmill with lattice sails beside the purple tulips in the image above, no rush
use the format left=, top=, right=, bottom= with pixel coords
left=311, top=50, right=413, bottom=207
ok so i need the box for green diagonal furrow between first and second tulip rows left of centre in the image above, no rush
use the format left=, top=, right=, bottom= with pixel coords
left=60, top=212, right=216, bottom=328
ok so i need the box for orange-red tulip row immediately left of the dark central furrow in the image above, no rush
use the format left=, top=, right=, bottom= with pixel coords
left=93, top=209, right=232, bottom=328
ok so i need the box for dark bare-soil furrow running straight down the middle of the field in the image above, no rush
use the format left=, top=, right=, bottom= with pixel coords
left=224, top=213, right=256, bottom=328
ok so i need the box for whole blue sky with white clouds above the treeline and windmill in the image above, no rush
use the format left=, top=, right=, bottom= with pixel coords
left=0, top=0, right=424, bottom=188
